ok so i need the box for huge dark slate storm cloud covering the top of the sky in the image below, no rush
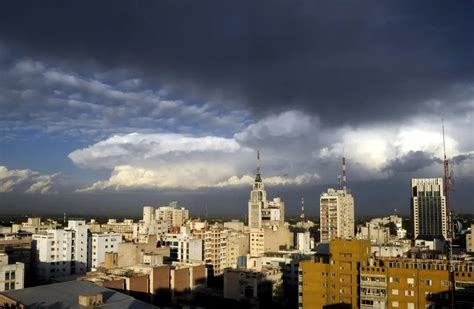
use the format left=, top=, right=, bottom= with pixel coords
left=0, top=0, right=474, bottom=124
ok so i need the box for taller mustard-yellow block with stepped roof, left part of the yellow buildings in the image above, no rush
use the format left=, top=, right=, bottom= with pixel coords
left=298, top=239, right=370, bottom=309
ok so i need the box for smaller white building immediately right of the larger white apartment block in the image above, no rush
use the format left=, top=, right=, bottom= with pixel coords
left=89, top=233, right=122, bottom=269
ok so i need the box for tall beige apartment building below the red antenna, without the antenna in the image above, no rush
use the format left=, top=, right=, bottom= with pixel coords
left=319, top=188, right=354, bottom=243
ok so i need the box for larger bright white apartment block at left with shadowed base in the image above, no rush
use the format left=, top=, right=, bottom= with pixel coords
left=32, top=220, right=89, bottom=281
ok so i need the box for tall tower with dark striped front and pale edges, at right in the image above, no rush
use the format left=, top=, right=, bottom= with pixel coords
left=411, top=178, right=448, bottom=239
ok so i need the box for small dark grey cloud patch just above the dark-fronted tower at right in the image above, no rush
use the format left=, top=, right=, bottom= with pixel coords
left=383, top=151, right=442, bottom=173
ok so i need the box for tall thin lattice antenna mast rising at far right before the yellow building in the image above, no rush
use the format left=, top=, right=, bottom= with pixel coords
left=441, top=118, right=456, bottom=308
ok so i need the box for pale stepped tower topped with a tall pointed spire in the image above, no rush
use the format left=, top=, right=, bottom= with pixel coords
left=248, top=150, right=268, bottom=228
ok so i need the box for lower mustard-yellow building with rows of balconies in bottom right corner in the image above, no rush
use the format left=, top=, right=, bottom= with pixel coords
left=360, top=258, right=474, bottom=309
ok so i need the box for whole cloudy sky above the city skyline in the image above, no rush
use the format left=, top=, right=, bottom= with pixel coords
left=0, top=0, right=474, bottom=218
